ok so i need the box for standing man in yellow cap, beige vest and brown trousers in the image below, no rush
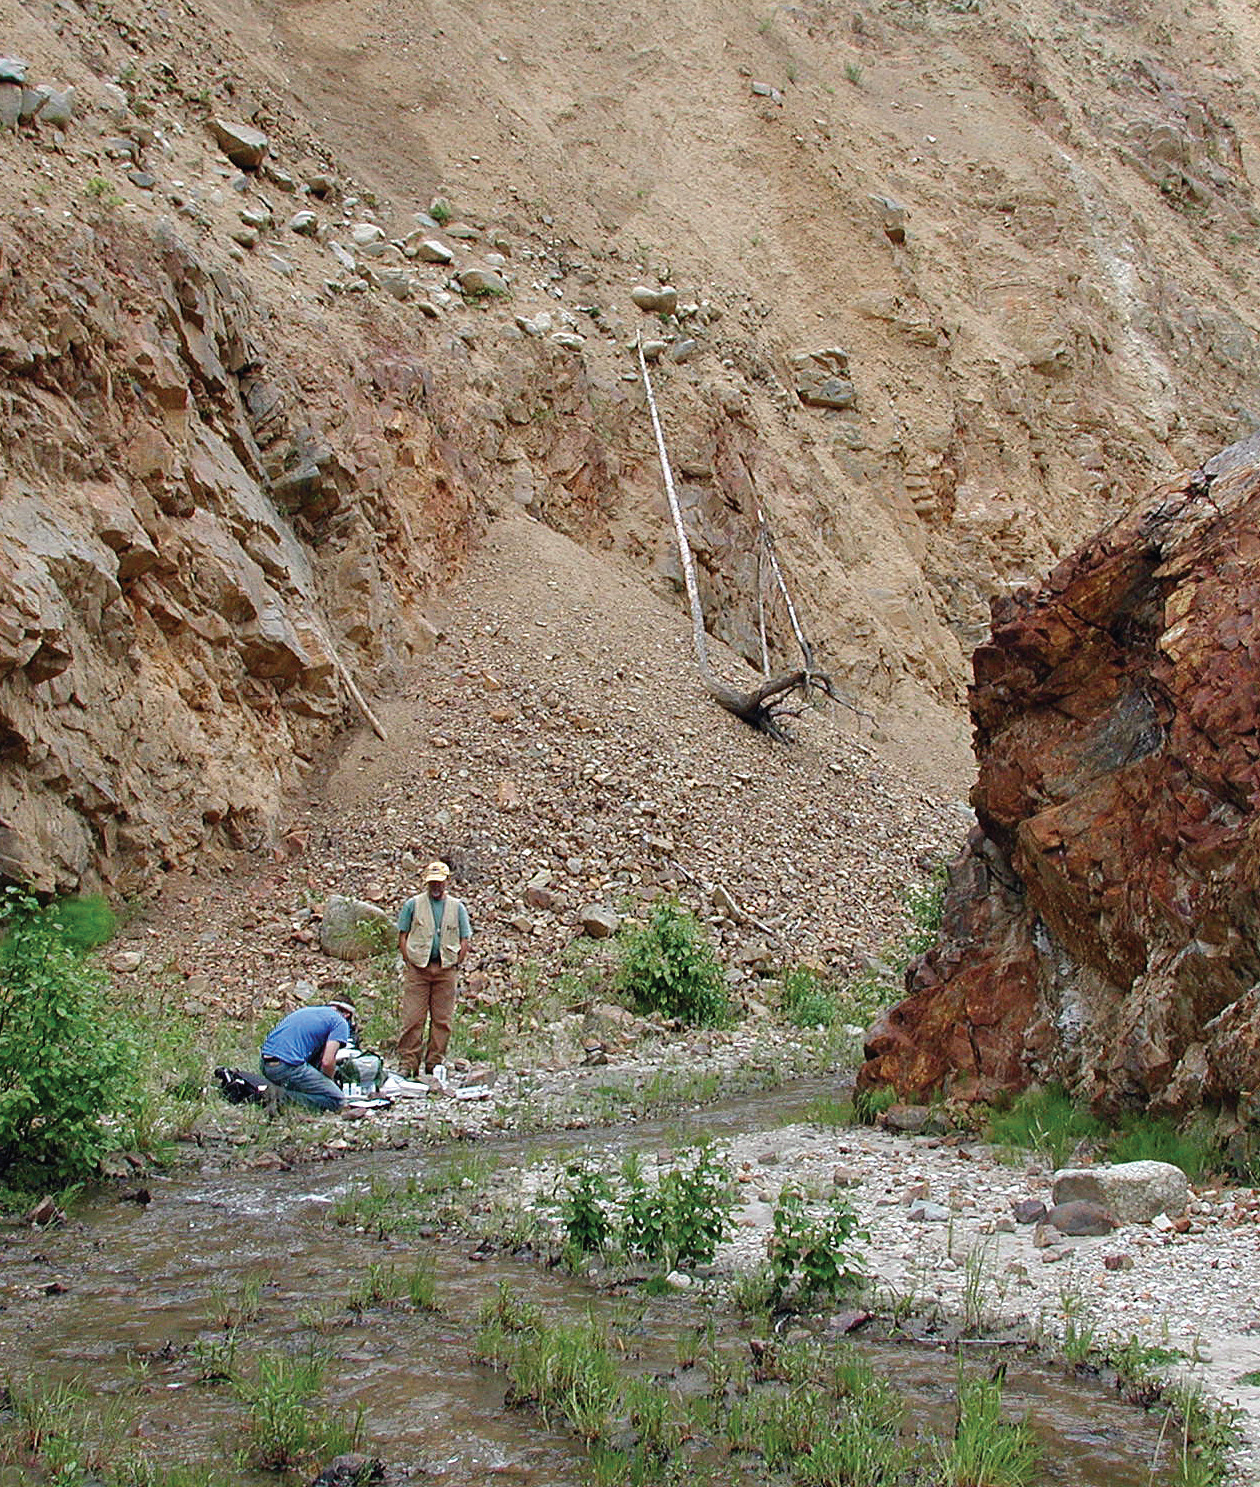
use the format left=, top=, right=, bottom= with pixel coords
left=399, top=862, right=473, bottom=1078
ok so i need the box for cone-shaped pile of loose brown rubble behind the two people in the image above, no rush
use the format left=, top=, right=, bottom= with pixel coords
left=133, top=515, right=968, bottom=1019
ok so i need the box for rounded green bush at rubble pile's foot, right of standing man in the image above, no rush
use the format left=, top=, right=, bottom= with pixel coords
left=617, top=903, right=730, bottom=1028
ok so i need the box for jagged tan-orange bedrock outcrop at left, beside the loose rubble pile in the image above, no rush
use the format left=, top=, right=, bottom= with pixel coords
left=0, top=223, right=484, bottom=891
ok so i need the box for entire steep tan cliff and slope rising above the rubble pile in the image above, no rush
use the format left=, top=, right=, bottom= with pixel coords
left=0, top=0, right=1260, bottom=891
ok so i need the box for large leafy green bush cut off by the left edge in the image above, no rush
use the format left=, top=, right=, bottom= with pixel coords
left=0, top=888, right=135, bottom=1188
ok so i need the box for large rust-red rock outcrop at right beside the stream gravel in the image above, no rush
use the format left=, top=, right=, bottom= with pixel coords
left=860, top=437, right=1260, bottom=1109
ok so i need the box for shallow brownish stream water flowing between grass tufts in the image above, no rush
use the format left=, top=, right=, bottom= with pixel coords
left=0, top=1086, right=1172, bottom=1487
